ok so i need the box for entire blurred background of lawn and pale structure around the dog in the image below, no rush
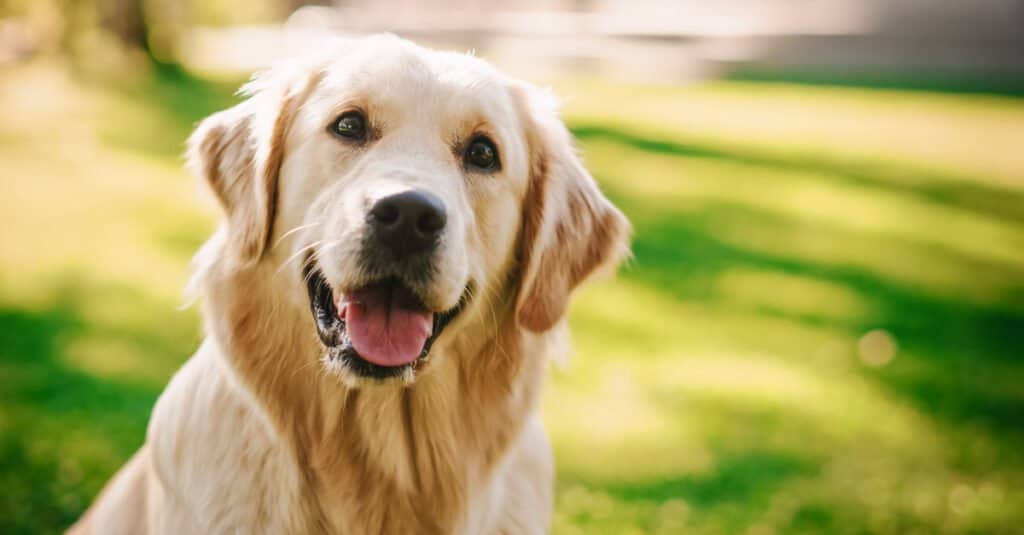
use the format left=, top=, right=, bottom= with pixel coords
left=0, top=0, right=1024, bottom=535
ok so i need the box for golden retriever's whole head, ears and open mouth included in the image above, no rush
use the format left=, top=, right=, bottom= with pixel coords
left=190, top=37, right=628, bottom=382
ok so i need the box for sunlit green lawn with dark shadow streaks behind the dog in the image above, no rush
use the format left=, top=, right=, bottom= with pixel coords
left=0, top=61, right=1024, bottom=534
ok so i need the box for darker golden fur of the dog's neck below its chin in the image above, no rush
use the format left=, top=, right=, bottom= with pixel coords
left=205, top=258, right=546, bottom=533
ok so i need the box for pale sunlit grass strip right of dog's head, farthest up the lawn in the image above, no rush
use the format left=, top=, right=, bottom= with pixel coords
left=555, top=80, right=1024, bottom=186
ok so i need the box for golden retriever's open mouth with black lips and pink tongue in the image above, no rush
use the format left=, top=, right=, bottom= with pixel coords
left=303, top=256, right=468, bottom=379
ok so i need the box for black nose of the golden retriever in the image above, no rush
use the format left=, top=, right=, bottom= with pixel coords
left=367, top=191, right=447, bottom=256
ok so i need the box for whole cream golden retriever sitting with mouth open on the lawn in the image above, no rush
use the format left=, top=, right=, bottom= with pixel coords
left=71, top=36, right=631, bottom=535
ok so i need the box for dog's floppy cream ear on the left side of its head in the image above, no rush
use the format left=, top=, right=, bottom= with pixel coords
left=186, top=67, right=305, bottom=265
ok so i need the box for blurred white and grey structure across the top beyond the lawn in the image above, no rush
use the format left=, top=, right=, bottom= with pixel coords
left=184, top=0, right=1024, bottom=81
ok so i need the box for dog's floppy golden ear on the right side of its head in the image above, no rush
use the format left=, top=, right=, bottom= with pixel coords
left=515, top=87, right=631, bottom=332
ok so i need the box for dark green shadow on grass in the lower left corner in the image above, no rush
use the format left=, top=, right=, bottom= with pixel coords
left=0, top=285, right=190, bottom=534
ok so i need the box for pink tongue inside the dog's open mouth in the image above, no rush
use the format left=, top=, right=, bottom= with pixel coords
left=341, top=284, right=433, bottom=366
